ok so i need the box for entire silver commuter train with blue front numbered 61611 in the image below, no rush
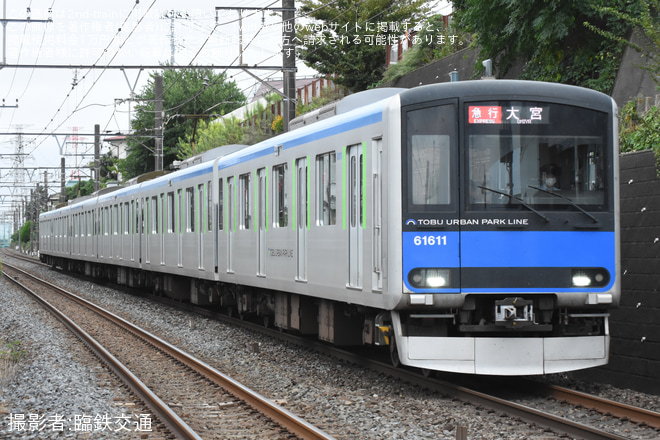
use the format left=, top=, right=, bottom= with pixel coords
left=40, top=80, right=620, bottom=375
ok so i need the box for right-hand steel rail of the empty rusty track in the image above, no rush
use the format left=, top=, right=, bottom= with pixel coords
left=5, top=264, right=334, bottom=440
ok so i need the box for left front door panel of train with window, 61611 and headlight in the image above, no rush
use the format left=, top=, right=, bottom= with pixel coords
left=401, top=100, right=461, bottom=293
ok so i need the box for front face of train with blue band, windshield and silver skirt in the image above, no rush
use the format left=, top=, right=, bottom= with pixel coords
left=390, top=81, right=620, bottom=375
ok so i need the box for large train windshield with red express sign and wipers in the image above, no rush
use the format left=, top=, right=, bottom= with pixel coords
left=464, top=101, right=609, bottom=211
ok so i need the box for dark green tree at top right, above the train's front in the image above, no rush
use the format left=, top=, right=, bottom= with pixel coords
left=453, top=0, right=639, bottom=93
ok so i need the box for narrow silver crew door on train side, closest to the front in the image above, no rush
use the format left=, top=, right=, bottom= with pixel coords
left=371, top=139, right=383, bottom=291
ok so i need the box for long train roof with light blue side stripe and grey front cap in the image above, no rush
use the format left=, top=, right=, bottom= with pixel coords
left=42, top=80, right=613, bottom=220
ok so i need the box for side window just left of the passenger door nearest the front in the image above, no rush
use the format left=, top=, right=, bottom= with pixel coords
left=316, top=152, right=337, bottom=226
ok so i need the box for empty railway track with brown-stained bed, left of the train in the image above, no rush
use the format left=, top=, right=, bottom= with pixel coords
left=3, top=262, right=331, bottom=439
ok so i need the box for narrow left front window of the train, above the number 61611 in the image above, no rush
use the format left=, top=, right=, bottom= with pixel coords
left=405, top=104, right=456, bottom=210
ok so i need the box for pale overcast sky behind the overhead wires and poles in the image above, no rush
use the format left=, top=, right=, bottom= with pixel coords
left=0, top=0, right=450, bottom=229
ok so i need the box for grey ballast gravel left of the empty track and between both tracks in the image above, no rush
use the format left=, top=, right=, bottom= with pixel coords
left=0, top=263, right=658, bottom=440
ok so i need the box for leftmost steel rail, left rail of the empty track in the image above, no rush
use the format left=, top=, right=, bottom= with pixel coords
left=2, top=263, right=202, bottom=440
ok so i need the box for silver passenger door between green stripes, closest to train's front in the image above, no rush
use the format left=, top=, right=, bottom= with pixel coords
left=346, top=144, right=364, bottom=288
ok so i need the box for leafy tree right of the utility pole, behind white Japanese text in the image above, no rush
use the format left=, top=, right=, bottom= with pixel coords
left=296, top=0, right=428, bottom=92
